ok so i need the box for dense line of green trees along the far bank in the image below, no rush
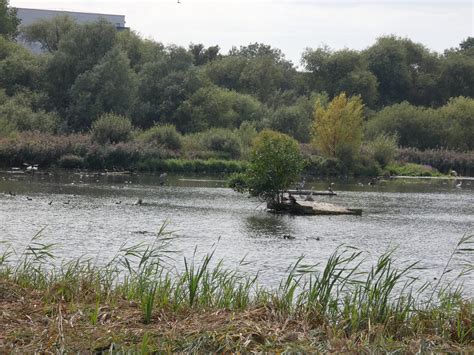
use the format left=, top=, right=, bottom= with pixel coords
left=0, top=0, right=474, bottom=151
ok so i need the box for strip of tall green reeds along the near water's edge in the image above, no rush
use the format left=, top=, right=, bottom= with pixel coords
left=0, top=225, right=474, bottom=344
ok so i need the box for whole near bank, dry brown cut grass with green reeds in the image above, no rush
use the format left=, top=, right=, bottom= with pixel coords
left=0, top=229, right=474, bottom=353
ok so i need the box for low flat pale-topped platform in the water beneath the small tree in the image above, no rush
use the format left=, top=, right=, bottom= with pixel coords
left=267, top=201, right=362, bottom=216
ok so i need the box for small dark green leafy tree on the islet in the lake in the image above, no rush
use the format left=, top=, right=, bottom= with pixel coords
left=230, top=130, right=304, bottom=203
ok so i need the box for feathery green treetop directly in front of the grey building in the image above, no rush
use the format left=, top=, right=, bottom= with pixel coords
left=21, top=16, right=76, bottom=53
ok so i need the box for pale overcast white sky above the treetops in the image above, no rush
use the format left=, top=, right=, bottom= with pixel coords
left=10, top=0, right=474, bottom=65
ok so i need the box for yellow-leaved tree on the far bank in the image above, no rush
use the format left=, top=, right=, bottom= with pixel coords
left=312, top=93, right=364, bottom=158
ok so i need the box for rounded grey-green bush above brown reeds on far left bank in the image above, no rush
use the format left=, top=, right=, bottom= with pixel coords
left=92, top=113, right=133, bottom=144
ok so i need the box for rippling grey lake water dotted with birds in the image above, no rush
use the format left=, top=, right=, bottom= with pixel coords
left=0, top=174, right=474, bottom=294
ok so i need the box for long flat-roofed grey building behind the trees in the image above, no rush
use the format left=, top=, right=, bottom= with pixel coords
left=17, top=7, right=128, bottom=52
